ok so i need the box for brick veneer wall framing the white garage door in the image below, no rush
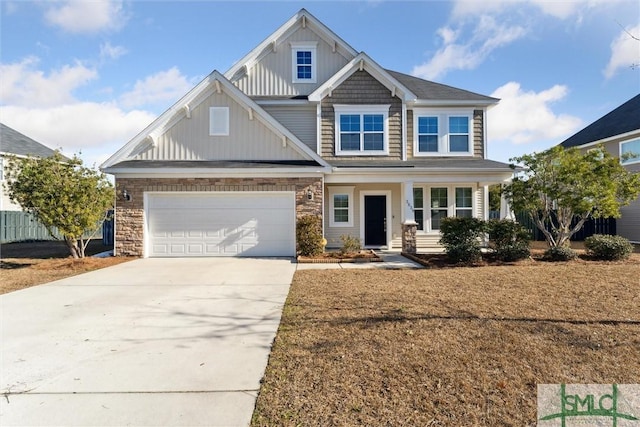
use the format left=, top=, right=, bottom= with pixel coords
left=114, top=178, right=322, bottom=256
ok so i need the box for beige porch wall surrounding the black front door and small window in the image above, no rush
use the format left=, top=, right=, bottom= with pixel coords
left=324, top=184, right=402, bottom=248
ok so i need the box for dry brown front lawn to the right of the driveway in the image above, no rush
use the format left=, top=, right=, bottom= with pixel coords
left=252, top=254, right=640, bottom=426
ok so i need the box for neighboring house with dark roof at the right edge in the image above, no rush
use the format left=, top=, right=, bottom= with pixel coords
left=560, top=95, right=640, bottom=243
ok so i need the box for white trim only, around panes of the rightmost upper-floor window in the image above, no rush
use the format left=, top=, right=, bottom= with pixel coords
left=413, top=108, right=475, bottom=157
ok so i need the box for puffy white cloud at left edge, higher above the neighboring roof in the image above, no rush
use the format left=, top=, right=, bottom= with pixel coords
left=0, top=56, right=98, bottom=107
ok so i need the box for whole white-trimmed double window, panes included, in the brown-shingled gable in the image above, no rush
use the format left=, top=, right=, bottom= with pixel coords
left=334, top=105, right=390, bottom=156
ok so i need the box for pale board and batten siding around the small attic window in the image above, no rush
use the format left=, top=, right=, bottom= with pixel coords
left=232, top=27, right=353, bottom=97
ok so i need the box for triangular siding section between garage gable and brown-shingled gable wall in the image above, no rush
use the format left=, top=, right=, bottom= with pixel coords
left=263, top=105, right=318, bottom=152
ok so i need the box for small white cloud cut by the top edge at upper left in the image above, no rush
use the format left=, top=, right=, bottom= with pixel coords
left=45, top=0, right=127, bottom=33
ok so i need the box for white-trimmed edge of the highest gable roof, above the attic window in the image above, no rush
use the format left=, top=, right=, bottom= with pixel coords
left=224, top=8, right=358, bottom=81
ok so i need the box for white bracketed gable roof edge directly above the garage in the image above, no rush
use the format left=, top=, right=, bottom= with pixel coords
left=100, top=70, right=328, bottom=169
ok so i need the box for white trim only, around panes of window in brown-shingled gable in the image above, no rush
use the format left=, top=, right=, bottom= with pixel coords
left=333, top=104, right=391, bottom=156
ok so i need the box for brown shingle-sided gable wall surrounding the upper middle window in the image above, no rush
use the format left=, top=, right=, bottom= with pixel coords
left=322, top=71, right=402, bottom=160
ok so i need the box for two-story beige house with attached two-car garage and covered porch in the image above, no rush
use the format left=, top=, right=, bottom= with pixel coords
left=101, top=9, right=512, bottom=257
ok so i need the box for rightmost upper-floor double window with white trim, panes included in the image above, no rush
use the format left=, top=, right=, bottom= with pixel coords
left=413, top=108, right=473, bottom=157
